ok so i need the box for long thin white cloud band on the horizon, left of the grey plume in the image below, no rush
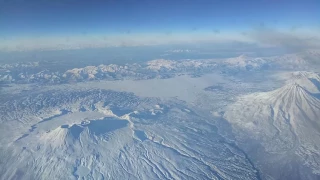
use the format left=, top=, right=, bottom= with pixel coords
left=0, top=31, right=245, bottom=51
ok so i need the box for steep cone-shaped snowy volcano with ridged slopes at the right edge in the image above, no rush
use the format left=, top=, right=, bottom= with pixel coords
left=224, top=72, right=320, bottom=178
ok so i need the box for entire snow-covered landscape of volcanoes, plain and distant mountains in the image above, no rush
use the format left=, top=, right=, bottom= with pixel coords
left=0, top=50, right=320, bottom=180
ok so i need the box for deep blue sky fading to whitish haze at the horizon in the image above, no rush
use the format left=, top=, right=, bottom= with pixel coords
left=0, top=0, right=320, bottom=51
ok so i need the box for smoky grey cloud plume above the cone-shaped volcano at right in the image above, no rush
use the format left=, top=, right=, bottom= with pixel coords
left=246, top=27, right=320, bottom=52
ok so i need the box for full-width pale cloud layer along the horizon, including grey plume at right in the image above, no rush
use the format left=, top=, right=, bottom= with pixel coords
left=0, top=27, right=320, bottom=51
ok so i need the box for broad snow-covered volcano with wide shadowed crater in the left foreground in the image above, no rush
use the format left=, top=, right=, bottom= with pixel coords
left=0, top=89, right=259, bottom=179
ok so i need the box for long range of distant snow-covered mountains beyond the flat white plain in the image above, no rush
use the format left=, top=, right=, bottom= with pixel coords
left=0, top=51, right=319, bottom=84
